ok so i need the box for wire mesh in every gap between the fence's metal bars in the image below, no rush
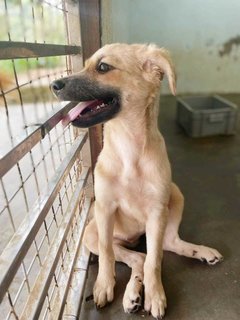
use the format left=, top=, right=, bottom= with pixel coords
left=0, top=0, right=92, bottom=319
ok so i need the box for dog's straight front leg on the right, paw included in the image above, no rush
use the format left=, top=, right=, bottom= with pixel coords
left=144, top=206, right=168, bottom=319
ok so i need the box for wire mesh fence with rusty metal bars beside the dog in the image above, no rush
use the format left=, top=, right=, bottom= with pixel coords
left=0, top=0, right=92, bottom=319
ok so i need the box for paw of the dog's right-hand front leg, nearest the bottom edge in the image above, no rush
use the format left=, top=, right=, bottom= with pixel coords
left=144, top=284, right=167, bottom=319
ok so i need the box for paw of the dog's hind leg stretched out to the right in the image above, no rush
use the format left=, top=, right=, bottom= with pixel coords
left=193, top=246, right=223, bottom=266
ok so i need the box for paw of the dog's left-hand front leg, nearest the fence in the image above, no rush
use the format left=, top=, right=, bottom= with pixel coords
left=93, top=277, right=115, bottom=309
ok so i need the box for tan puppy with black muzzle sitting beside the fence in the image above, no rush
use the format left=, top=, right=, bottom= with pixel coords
left=52, top=44, right=222, bottom=319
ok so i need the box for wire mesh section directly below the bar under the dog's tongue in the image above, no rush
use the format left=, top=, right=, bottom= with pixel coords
left=0, top=124, right=81, bottom=253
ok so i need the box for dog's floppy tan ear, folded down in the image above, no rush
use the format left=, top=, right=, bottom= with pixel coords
left=143, top=45, right=176, bottom=96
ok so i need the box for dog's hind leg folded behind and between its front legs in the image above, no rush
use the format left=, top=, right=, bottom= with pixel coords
left=83, top=219, right=146, bottom=313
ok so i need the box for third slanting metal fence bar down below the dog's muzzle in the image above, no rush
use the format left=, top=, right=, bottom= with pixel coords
left=20, top=168, right=90, bottom=320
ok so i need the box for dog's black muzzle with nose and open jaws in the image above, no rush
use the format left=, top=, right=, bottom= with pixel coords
left=51, top=75, right=121, bottom=128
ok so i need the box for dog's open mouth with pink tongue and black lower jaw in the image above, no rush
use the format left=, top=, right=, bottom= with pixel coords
left=62, top=97, right=120, bottom=128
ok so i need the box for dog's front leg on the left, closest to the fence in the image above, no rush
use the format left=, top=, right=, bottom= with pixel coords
left=93, top=201, right=116, bottom=308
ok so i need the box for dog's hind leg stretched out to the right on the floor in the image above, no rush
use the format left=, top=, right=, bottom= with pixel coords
left=163, top=184, right=223, bottom=265
